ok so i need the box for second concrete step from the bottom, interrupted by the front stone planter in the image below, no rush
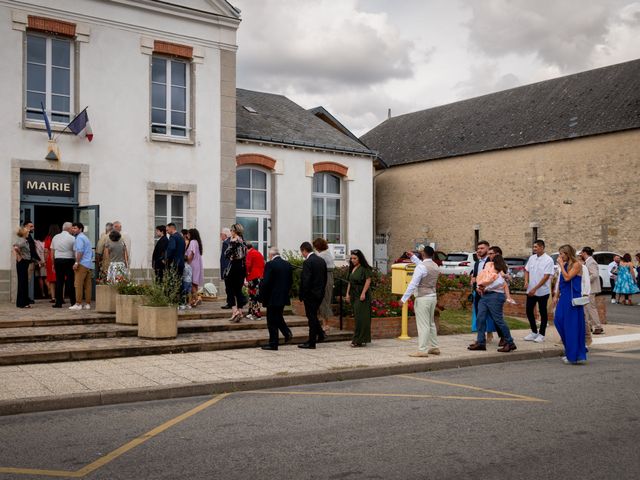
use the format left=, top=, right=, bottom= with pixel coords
left=0, top=316, right=308, bottom=345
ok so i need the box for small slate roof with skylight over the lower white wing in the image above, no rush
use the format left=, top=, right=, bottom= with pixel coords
left=236, top=88, right=376, bottom=155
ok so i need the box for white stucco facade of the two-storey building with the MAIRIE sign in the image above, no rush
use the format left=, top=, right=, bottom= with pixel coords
left=0, top=0, right=236, bottom=276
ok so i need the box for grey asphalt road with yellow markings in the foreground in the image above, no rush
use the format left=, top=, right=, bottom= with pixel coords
left=0, top=347, right=640, bottom=480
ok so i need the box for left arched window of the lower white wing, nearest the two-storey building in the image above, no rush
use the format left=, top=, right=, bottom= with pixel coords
left=236, top=167, right=271, bottom=256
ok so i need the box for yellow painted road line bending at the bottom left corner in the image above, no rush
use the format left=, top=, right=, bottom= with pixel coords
left=0, top=393, right=230, bottom=478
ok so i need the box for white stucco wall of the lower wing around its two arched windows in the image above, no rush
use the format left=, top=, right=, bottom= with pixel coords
left=236, top=142, right=373, bottom=263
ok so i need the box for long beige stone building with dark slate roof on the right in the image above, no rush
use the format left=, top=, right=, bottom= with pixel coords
left=362, top=60, right=640, bottom=264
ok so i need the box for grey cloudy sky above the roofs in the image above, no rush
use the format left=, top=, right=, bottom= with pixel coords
left=231, top=0, right=640, bottom=135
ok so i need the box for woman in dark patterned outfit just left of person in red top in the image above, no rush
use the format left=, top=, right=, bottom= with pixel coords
left=223, top=223, right=247, bottom=323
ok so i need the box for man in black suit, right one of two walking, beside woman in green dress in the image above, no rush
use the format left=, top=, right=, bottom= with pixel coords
left=298, top=242, right=327, bottom=348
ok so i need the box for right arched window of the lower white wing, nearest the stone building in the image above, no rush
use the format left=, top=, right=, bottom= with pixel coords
left=313, top=172, right=342, bottom=243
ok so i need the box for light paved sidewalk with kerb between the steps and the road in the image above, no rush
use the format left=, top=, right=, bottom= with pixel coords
left=0, top=325, right=640, bottom=415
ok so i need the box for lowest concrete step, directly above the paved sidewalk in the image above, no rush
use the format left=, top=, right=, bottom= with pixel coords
left=0, top=327, right=353, bottom=365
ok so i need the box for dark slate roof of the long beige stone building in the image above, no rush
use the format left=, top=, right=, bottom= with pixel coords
left=360, top=60, right=640, bottom=167
